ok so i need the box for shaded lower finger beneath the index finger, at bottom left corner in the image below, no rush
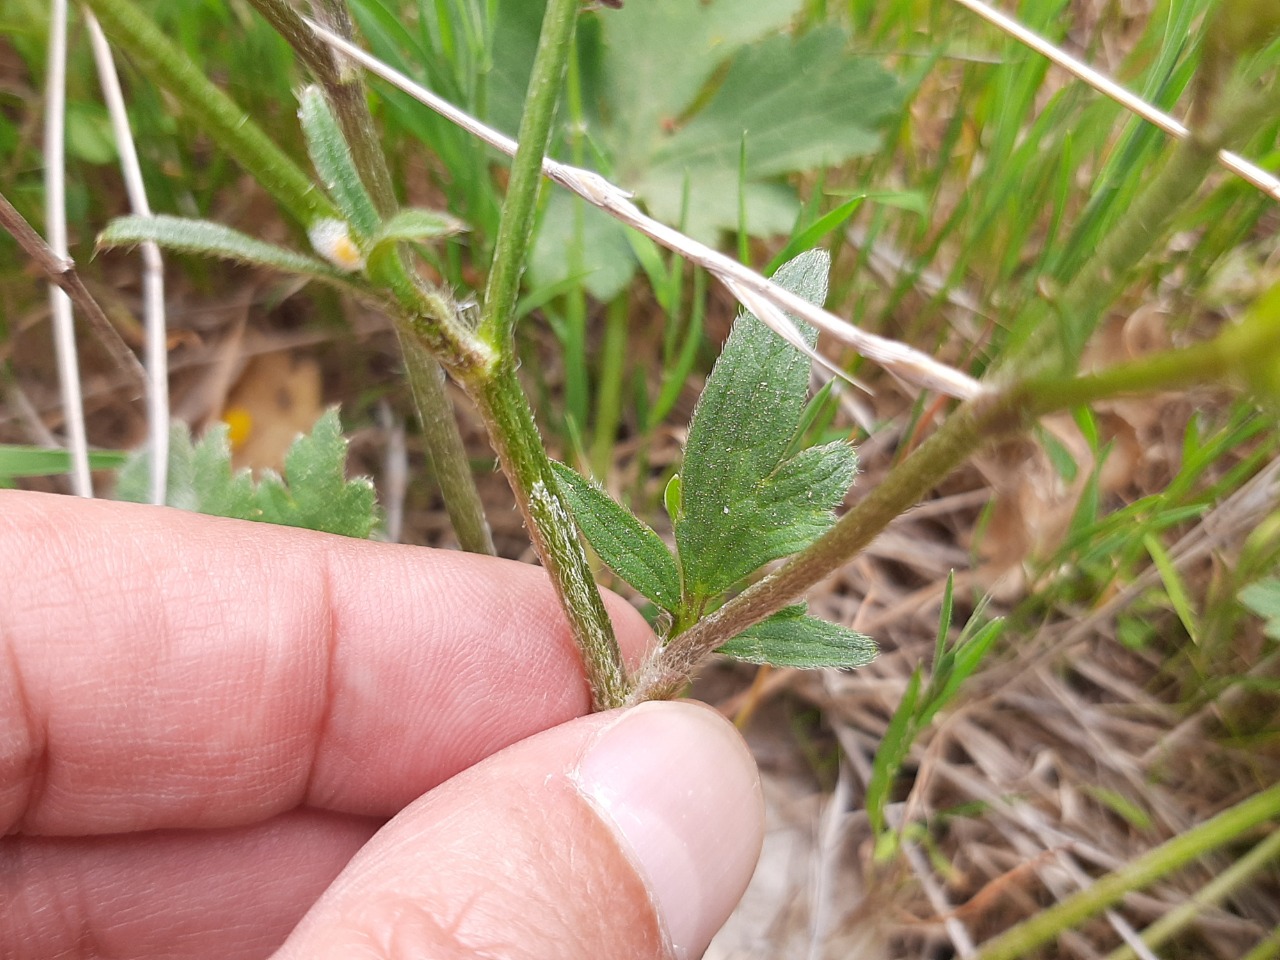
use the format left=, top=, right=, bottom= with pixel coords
left=0, top=810, right=379, bottom=960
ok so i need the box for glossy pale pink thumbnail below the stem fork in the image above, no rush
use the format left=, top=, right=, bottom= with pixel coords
left=575, top=701, right=764, bottom=960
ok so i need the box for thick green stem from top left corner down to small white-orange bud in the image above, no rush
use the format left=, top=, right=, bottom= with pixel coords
left=84, top=0, right=338, bottom=227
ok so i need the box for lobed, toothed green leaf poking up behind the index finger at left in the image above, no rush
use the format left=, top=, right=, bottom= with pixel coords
left=115, top=408, right=378, bottom=538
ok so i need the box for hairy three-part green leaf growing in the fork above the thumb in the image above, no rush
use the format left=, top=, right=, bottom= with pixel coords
left=554, top=251, right=876, bottom=668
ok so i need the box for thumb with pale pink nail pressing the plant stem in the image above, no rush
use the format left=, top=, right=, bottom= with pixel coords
left=276, top=701, right=763, bottom=960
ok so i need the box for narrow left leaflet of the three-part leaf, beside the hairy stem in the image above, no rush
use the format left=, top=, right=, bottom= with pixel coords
left=552, top=461, right=680, bottom=612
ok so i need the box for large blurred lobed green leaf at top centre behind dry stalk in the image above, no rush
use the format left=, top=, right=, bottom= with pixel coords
left=517, top=0, right=905, bottom=293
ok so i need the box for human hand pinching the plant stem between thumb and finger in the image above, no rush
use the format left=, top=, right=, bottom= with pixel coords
left=0, top=492, right=762, bottom=960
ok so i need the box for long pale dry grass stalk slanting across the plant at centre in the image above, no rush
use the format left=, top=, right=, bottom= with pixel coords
left=307, top=20, right=984, bottom=399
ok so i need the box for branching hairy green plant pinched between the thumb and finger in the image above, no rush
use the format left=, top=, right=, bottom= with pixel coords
left=17, top=0, right=1280, bottom=709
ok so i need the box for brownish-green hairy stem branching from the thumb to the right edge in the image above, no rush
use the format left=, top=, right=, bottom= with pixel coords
left=631, top=285, right=1280, bottom=701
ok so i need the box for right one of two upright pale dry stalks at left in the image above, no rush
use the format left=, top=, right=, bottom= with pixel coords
left=84, top=9, right=169, bottom=504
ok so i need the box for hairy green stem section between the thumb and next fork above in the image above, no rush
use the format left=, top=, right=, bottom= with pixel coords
left=468, top=358, right=627, bottom=710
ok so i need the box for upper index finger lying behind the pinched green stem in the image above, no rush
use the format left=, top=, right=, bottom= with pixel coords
left=0, top=492, right=652, bottom=835
